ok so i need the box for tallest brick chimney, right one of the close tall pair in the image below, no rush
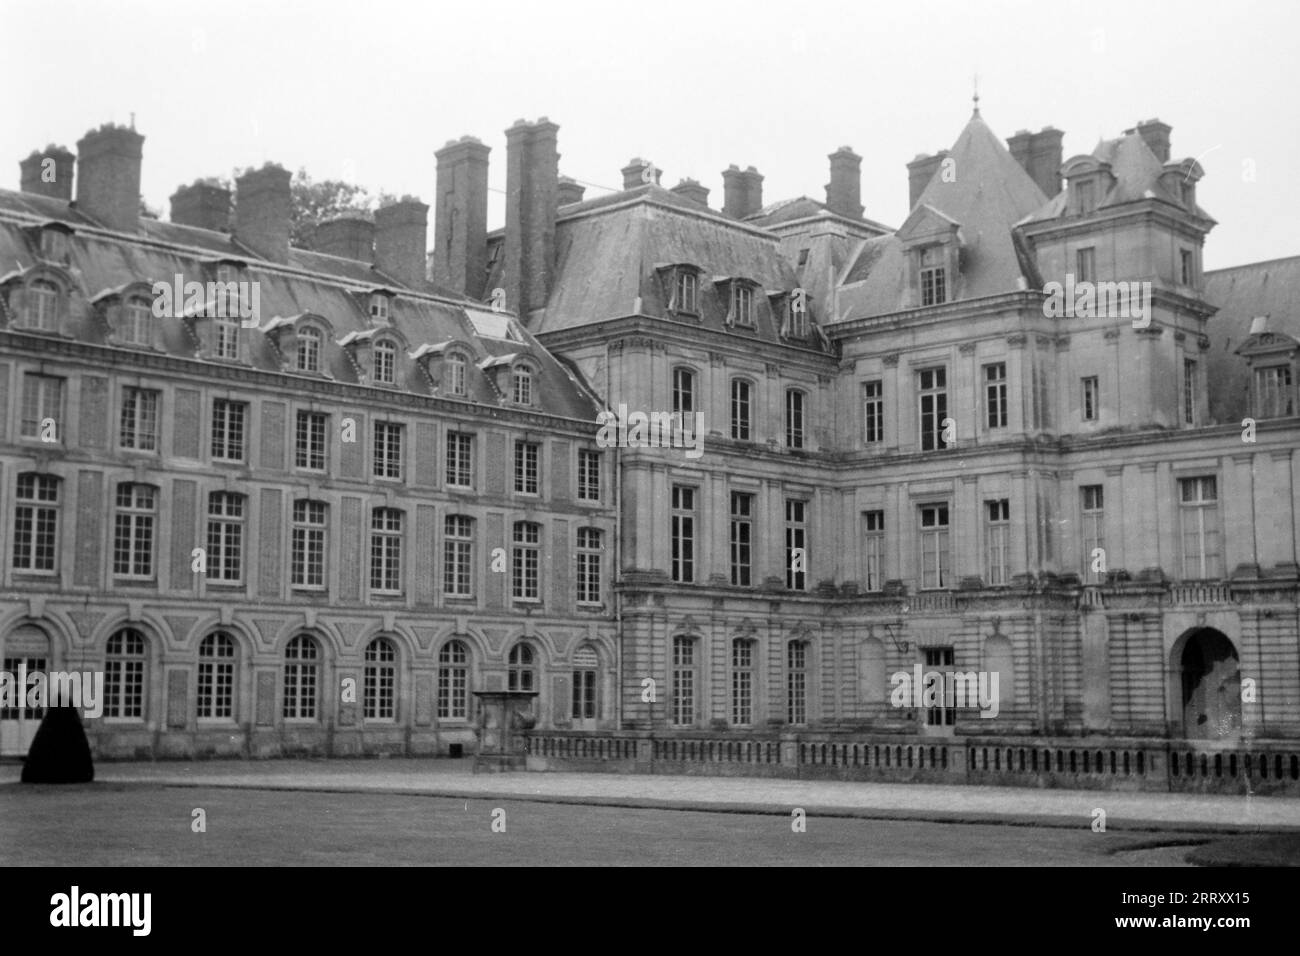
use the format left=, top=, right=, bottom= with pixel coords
left=504, top=116, right=560, bottom=323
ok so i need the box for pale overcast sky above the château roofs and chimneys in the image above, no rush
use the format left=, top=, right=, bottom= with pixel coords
left=0, top=0, right=1300, bottom=268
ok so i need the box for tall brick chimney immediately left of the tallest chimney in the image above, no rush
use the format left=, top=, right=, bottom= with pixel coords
left=433, top=137, right=491, bottom=299
